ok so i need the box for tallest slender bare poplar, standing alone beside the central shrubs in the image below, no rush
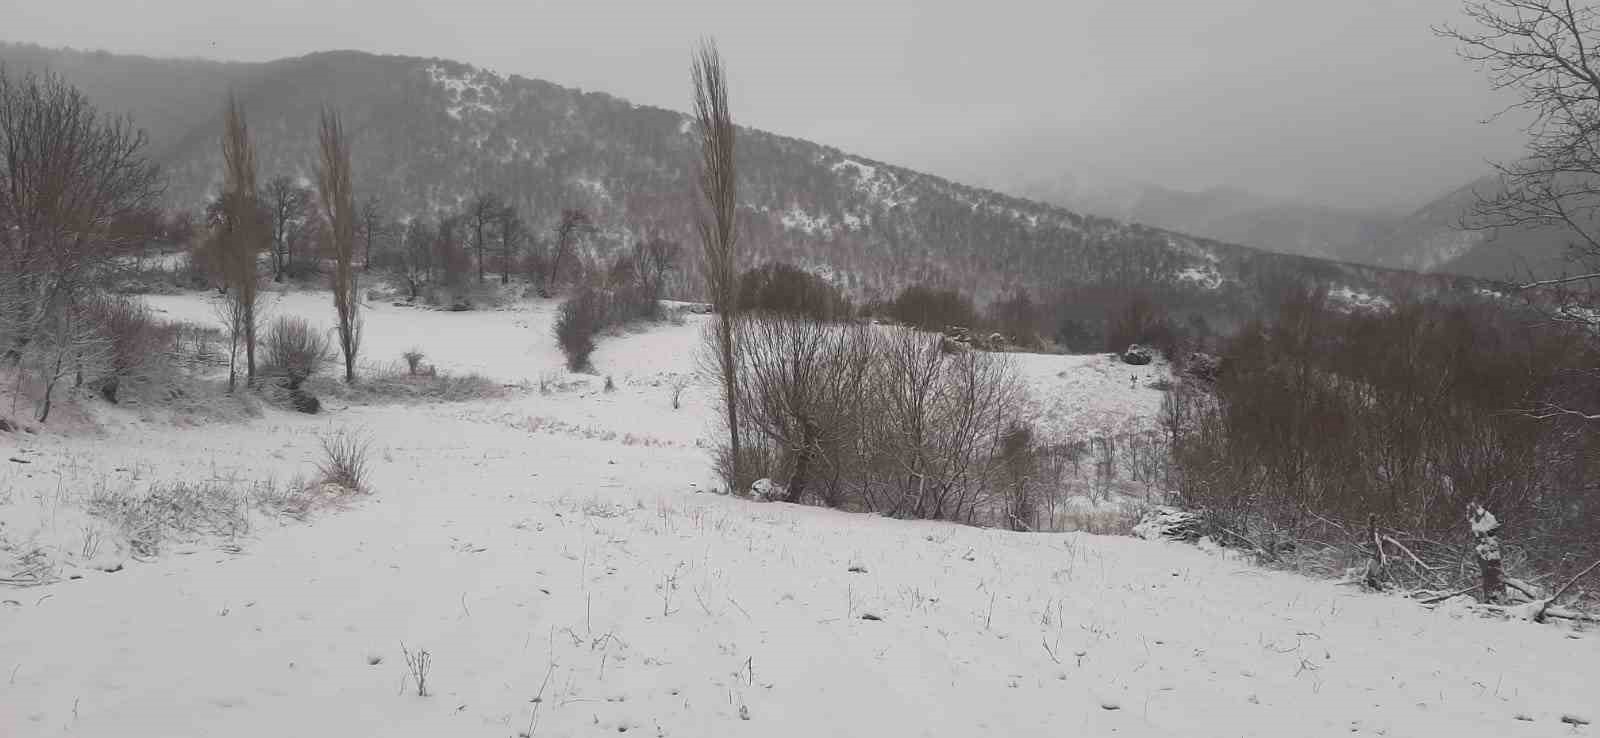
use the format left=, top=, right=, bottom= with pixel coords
left=690, top=40, right=746, bottom=490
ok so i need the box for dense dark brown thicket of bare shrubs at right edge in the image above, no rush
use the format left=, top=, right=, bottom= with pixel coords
left=1163, top=290, right=1600, bottom=601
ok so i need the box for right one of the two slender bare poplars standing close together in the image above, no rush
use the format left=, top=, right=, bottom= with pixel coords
left=317, top=107, right=362, bottom=383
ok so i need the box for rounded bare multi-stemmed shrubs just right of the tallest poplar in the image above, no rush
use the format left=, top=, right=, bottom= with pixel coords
left=707, top=312, right=1043, bottom=530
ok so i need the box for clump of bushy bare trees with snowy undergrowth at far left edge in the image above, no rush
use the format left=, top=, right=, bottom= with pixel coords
left=0, top=69, right=162, bottom=423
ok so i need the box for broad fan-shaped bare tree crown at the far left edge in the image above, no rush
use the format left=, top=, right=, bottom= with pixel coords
left=0, top=69, right=162, bottom=363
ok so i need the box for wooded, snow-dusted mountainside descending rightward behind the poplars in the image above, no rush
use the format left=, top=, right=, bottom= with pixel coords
left=0, top=45, right=1478, bottom=307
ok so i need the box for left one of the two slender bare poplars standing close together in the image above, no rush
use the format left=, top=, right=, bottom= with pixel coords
left=213, top=93, right=267, bottom=389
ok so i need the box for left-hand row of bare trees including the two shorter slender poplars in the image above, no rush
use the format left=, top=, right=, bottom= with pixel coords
left=0, top=69, right=371, bottom=423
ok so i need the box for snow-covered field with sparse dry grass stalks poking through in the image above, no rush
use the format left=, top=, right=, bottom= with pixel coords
left=0, top=293, right=1600, bottom=738
